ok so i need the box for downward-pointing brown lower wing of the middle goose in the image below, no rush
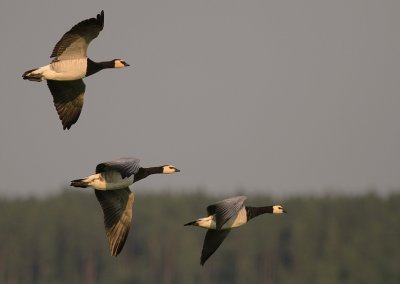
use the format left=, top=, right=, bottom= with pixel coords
left=95, top=187, right=134, bottom=256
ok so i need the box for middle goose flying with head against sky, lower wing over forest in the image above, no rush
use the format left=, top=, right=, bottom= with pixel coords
left=71, top=158, right=180, bottom=256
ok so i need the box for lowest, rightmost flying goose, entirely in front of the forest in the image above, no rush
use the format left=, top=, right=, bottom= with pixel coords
left=184, top=196, right=287, bottom=265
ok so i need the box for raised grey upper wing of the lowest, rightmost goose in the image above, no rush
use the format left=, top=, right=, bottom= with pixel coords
left=207, top=196, right=247, bottom=230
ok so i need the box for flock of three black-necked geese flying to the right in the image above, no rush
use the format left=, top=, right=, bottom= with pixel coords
left=22, top=11, right=286, bottom=265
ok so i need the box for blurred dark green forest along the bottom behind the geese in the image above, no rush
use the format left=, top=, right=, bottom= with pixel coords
left=0, top=190, right=400, bottom=284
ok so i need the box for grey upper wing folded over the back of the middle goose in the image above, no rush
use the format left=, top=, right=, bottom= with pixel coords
left=96, top=158, right=140, bottom=178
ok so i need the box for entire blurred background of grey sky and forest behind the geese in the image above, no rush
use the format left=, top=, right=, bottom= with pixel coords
left=0, top=0, right=400, bottom=283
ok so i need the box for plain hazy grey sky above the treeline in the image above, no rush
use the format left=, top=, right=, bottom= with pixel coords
left=0, top=0, right=400, bottom=195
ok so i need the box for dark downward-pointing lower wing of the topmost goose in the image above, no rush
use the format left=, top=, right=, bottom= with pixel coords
left=47, top=79, right=86, bottom=129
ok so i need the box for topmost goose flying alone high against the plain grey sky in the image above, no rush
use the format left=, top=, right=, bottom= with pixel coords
left=22, top=11, right=129, bottom=130
